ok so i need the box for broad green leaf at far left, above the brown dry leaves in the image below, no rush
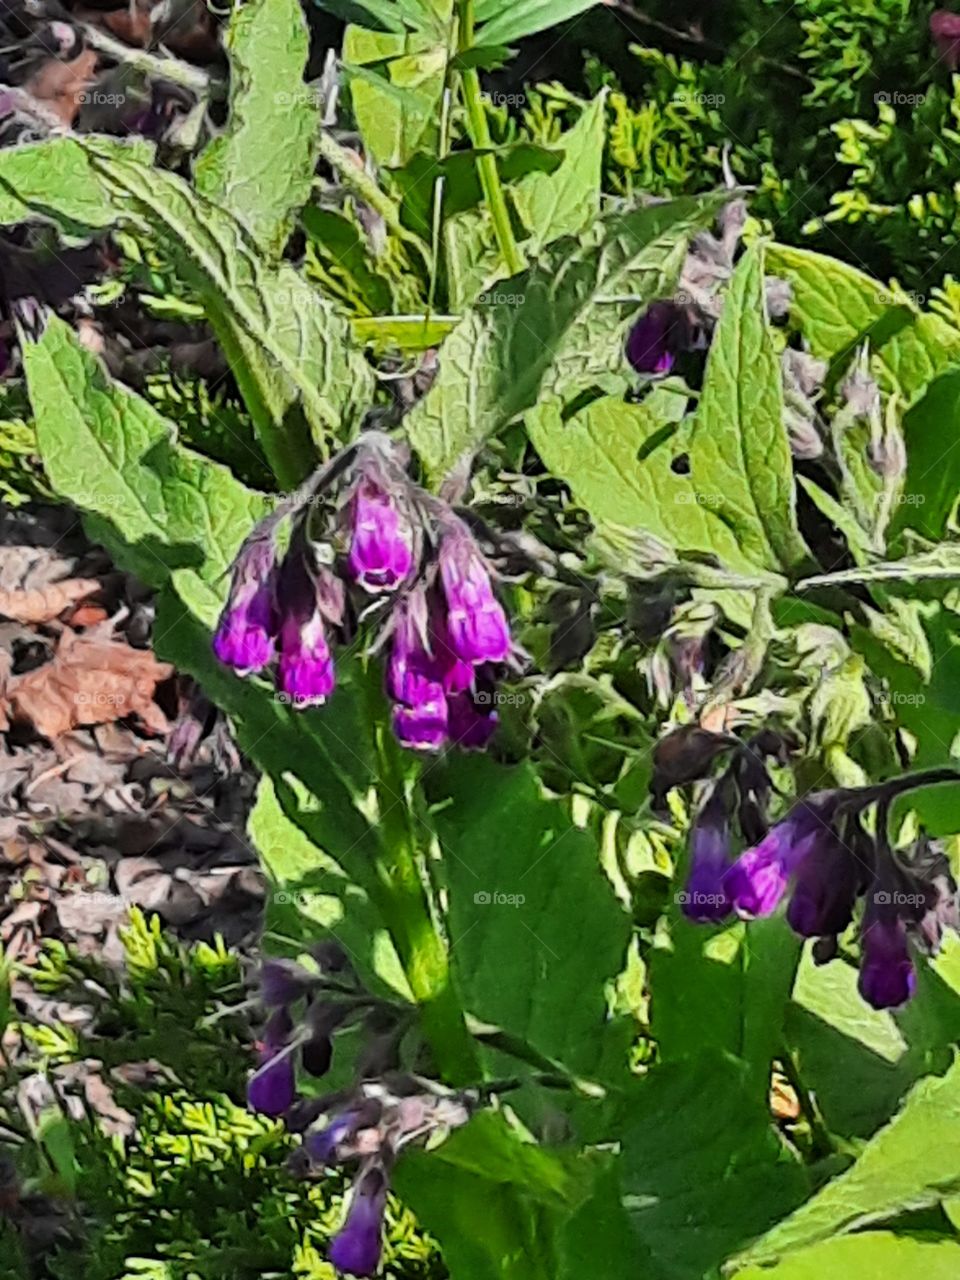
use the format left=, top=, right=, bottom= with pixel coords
left=23, top=316, right=268, bottom=622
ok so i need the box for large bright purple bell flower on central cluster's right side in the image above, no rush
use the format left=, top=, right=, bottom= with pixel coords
left=440, top=522, right=512, bottom=663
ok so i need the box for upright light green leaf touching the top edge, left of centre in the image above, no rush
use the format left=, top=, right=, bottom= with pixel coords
left=195, top=0, right=320, bottom=257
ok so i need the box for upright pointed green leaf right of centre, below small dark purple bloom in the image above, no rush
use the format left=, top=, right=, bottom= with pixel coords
left=690, top=246, right=808, bottom=571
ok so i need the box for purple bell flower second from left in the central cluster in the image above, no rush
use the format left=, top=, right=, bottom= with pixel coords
left=276, top=544, right=335, bottom=707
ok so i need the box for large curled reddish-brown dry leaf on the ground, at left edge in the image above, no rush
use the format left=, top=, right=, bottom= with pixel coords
left=5, top=631, right=173, bottom=739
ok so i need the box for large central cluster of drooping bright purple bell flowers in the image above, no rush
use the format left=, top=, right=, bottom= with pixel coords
left=214, top=431, right=516, bottom=750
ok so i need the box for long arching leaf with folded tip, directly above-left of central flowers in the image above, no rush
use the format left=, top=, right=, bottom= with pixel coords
left=87, top=150, right=372, bottom=488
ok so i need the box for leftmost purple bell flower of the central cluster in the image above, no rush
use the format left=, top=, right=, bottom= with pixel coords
left=214, top=535, right=278, bottom=676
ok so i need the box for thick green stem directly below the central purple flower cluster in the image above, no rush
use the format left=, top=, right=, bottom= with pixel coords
left=374, top=712, right=483, bottom=1085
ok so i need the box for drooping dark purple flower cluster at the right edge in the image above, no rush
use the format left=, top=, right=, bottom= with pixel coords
left=681, top=750, right=960, bottom=1009
